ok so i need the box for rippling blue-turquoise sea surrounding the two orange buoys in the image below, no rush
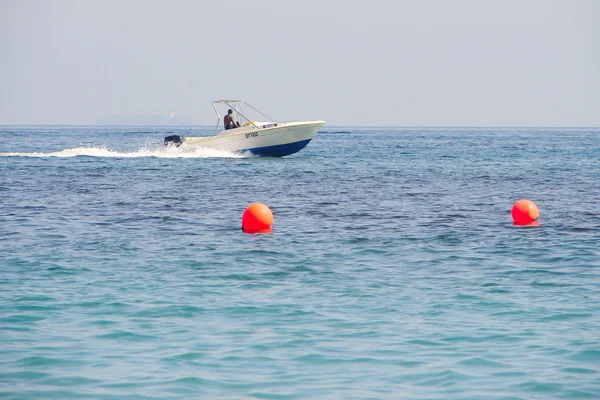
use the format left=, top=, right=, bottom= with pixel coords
left=0, top=126, right=600, bottom=399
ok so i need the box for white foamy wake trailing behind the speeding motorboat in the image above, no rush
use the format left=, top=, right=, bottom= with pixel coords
left=0, top=146, right=248, bottom=158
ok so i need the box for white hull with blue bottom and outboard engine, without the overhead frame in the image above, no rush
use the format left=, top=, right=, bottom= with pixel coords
left=165, top=121, right=325, bottom=157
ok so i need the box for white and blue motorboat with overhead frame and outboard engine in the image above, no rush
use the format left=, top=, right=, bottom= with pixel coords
left=164, top=100, right=325, bottom=157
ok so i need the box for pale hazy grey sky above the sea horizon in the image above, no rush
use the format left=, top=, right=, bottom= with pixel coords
left=0, top=0, right=600, bottom=126
